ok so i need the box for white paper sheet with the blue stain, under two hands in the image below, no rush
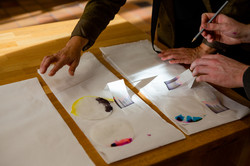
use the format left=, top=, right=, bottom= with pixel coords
left=100, top=40, right=250, bottom=135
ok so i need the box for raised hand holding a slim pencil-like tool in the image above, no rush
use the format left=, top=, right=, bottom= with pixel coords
left=200, top=13, right=250, bottom=45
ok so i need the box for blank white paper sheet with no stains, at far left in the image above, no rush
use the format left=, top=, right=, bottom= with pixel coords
left=0, top=78, right=94, bottom=166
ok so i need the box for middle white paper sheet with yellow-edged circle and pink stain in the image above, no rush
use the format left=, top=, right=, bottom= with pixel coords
left=38, top=52, right=185, bottom=163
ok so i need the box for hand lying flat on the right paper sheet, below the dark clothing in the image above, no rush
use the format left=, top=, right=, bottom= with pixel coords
left=158, top=43, right=215, bottom=64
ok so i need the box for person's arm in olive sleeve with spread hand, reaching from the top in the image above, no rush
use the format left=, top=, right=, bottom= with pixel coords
left=40, top=0, right=126, bottom=76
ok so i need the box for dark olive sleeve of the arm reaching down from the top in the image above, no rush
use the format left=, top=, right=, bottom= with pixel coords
left=71, top=0, right=126, bottom=50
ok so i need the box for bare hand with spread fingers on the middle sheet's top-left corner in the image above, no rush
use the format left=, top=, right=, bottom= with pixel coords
left=40, top=36, right=88, bottom=76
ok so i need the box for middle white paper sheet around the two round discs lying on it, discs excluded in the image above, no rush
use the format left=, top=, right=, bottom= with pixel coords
left=38, top=53, right=185, bottom=163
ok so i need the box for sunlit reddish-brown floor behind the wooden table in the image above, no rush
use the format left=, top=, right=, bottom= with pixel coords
left=0, top=0, right=153, bottom=33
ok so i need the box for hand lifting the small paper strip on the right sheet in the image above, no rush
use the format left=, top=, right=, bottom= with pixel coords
left=190, top=54, right=249, bottom=88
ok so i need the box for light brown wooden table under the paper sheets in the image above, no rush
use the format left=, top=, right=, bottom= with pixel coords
left=0, top=16, right=250, bottom=166
